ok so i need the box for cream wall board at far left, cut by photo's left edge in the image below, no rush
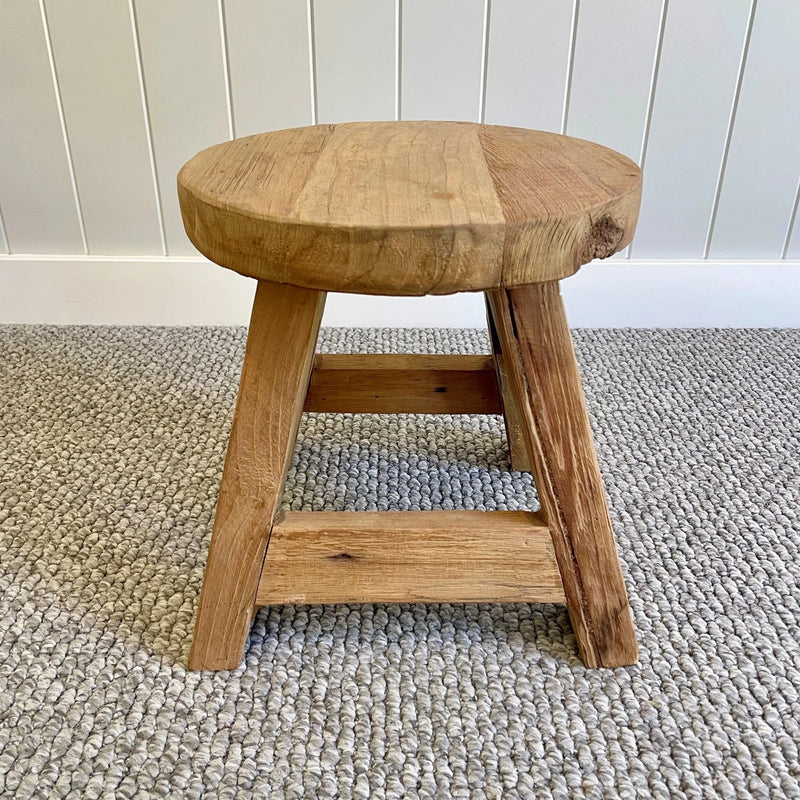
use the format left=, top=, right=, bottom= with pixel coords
left=0, top=0, right=84, bottom=253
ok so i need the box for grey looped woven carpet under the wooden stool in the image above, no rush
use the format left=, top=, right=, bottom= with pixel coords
left=0, top=327, right=800, bottom=800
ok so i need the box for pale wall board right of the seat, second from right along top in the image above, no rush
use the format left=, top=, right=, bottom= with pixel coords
left=632, top=0, right=751, bottom=258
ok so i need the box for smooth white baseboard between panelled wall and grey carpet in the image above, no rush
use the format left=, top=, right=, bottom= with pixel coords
left=0, top=255, right=800, bottom=328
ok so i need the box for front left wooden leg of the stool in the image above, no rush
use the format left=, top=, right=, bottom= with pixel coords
left=189, top=281, right=325, bottom=670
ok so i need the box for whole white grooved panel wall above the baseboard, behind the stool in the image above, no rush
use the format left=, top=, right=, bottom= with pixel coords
left=0, top=0, right=800, bottom=290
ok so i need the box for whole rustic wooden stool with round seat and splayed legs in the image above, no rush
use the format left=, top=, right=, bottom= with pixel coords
left=178, top=122, right=641, bottom=669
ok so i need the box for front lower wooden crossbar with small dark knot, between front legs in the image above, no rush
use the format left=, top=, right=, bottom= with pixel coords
left=256, top=511, right=564, bottom=605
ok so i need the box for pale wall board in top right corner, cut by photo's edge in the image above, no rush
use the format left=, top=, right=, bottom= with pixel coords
left=710, top=0, right=800, bottom=258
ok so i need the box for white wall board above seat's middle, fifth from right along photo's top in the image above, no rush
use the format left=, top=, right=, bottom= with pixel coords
left=400, top=0, right=486, bottom=120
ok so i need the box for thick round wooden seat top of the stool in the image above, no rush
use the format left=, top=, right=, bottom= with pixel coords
left=178, top=122, right=641, bottom=295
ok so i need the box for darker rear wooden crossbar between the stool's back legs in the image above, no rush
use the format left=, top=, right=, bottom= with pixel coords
left=304, top=353, right=500, bottom=414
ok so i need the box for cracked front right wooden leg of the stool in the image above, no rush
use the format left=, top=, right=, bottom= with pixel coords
left=487, top=281, right=638, bottom=667
